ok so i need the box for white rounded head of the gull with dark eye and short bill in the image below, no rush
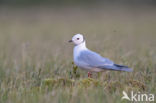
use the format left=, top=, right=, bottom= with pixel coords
left=69, top=34, right=85, bottom=45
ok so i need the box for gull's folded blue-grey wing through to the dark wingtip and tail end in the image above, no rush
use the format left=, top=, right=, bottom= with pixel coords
left=78, top=50, right=132, bottom=72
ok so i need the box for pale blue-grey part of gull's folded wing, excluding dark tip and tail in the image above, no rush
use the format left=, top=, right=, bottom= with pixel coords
left=78, top=50, right=114, bottom=67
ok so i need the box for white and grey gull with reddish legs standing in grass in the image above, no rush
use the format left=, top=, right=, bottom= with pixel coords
left=69, top=34, right=132, bottom=77
